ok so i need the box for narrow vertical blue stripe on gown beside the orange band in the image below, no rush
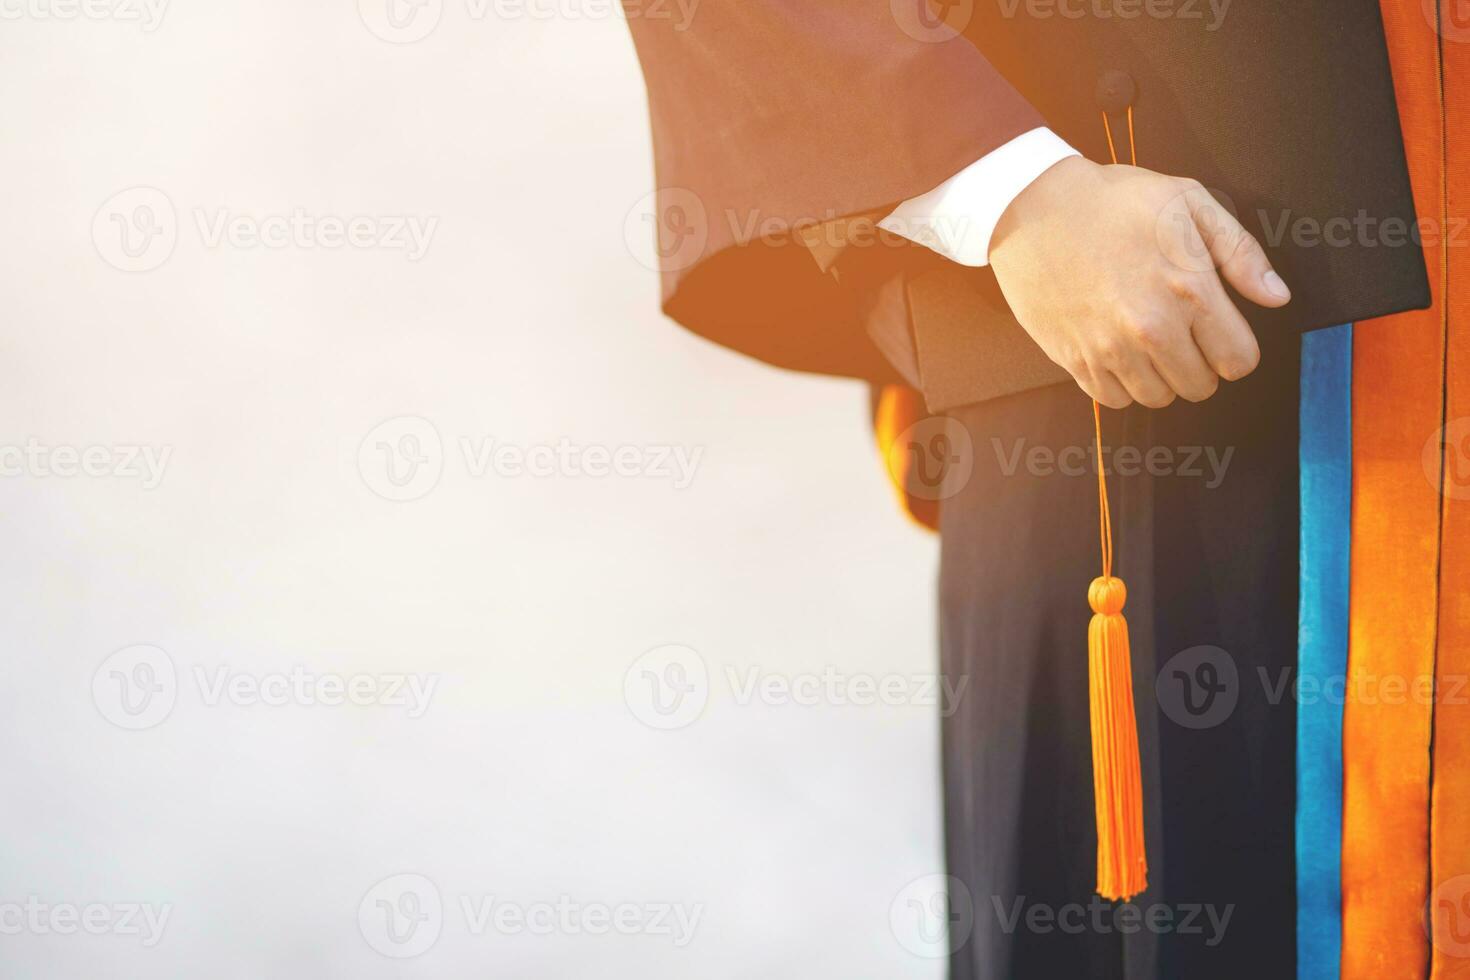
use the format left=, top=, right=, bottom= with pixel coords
left=1297, top=323, right=1352, bottom=980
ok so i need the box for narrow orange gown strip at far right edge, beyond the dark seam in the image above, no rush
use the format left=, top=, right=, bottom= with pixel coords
left=1424, top=17, right=1470, bottom=980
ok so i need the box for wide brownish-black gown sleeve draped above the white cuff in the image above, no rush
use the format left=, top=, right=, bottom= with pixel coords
left=623, top=0, right=1044, bottom=382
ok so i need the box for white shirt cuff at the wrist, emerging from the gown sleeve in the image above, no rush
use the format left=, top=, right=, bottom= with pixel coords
left=878, top=126, right=1080, bottom=266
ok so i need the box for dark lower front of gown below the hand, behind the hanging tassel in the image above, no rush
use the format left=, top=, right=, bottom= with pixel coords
left=941, top=338, right=1299, bottom=980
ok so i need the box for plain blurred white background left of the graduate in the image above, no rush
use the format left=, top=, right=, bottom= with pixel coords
left=0, top=0, right=942, bottom=980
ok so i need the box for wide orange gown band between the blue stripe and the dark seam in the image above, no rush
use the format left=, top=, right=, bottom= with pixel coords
left=1346, top=0, right=1445, bottom=980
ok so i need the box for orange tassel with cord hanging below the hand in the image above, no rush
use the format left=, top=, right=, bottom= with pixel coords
left=1088, top=401, right=1148, bottom=902
